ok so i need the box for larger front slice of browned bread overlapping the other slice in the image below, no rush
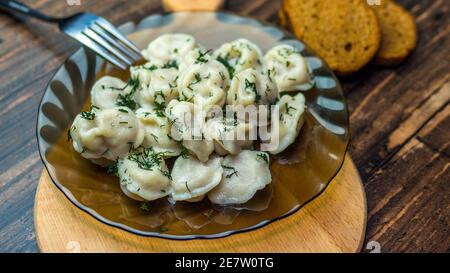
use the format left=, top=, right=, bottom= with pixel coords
left=283, top=0, right=381, bottom=75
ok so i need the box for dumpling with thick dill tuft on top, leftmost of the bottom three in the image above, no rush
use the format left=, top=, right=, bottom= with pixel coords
left=117, top=148, right=170, bottom=201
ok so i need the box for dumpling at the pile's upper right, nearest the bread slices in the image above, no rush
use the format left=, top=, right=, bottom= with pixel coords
left=264, top=45, right=312, bottom=92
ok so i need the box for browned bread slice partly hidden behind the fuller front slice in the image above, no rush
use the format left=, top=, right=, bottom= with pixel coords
left=371, top=0, right=417, bottom=65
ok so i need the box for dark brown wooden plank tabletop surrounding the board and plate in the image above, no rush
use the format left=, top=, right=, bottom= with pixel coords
left=0, top=0, right=450, bottom=252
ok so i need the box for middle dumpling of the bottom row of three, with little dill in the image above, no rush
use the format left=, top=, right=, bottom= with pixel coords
left=171, top=156, right=223, bottom=201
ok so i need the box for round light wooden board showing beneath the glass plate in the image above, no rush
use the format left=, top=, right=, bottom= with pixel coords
left=34, top=156, right=367, bottom=252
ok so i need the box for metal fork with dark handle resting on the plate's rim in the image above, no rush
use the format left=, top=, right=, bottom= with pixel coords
left=0, top=0, right=141, bottom=70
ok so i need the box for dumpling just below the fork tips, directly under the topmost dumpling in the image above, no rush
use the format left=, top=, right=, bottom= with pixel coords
left=132, top=68, right=178, bottom=108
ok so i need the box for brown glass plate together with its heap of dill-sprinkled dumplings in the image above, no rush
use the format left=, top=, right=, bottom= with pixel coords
left=37, top=12, right=349, bottom=239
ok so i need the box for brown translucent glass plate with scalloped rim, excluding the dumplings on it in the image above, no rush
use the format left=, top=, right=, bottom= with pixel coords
left=37, top=12, right=349, bottom=239
